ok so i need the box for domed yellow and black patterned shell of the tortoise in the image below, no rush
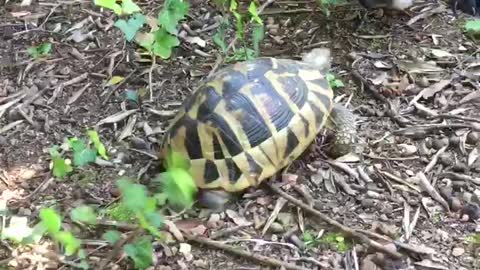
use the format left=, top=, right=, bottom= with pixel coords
left=162, top=58, right=333, bottom=192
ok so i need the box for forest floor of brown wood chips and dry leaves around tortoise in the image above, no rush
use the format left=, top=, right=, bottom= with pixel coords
left=0, top=0, right=480, bottom=270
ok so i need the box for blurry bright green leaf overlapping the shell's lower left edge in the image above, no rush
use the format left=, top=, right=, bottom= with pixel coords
left=158, top=168, right=197, bottom=208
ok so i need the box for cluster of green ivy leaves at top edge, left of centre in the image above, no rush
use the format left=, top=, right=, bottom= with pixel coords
left=94, top=0, right=190, bottom=59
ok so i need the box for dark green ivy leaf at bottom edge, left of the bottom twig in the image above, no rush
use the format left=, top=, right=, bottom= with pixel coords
left=123, top=236, right=153, bottom=269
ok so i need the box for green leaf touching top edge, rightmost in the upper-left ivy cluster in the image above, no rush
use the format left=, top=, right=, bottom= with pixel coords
left=158, top=0, right=189, bottom=35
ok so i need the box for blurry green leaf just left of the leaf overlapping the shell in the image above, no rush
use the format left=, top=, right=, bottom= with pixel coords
left=117, top=178, right=148, bottom=213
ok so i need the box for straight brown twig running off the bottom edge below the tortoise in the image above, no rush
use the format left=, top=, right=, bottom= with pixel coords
left=184, top=234, right=306, bottom=270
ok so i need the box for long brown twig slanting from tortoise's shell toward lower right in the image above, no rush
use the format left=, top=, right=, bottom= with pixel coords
left=267, top=183, right=402, bottom=258
